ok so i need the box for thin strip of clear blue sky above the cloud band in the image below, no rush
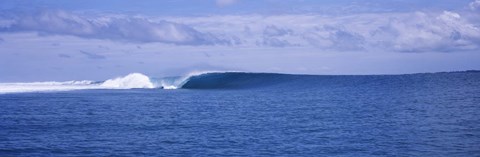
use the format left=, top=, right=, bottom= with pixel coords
left=1, top=0, right=472, bottom=15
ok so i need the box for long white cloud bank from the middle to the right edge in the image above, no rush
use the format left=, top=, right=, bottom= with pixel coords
left=173, top=11, right=480, bottom=52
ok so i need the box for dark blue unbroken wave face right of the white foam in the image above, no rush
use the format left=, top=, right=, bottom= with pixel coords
left=179, top=71, right=480, bottom=91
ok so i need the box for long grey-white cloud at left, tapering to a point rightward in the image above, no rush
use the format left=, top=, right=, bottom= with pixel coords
left=0, top=11, right=229, bottom=45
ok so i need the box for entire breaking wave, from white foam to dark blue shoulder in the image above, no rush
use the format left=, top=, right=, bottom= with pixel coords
left=0, top=71, right=479, bottom=94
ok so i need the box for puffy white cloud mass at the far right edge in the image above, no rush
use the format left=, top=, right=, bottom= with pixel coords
left=385, top=11, right=480, bottom=52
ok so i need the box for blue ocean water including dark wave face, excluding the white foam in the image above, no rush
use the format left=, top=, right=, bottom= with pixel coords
left=0, top=72, right=480, bottom=156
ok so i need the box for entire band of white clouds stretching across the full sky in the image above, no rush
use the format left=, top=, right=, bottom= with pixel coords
left=0, top=11, right=480, bottom=52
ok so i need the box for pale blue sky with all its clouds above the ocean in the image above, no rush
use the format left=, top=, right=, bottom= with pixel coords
left=0, top=0, right=480, bottom=82
